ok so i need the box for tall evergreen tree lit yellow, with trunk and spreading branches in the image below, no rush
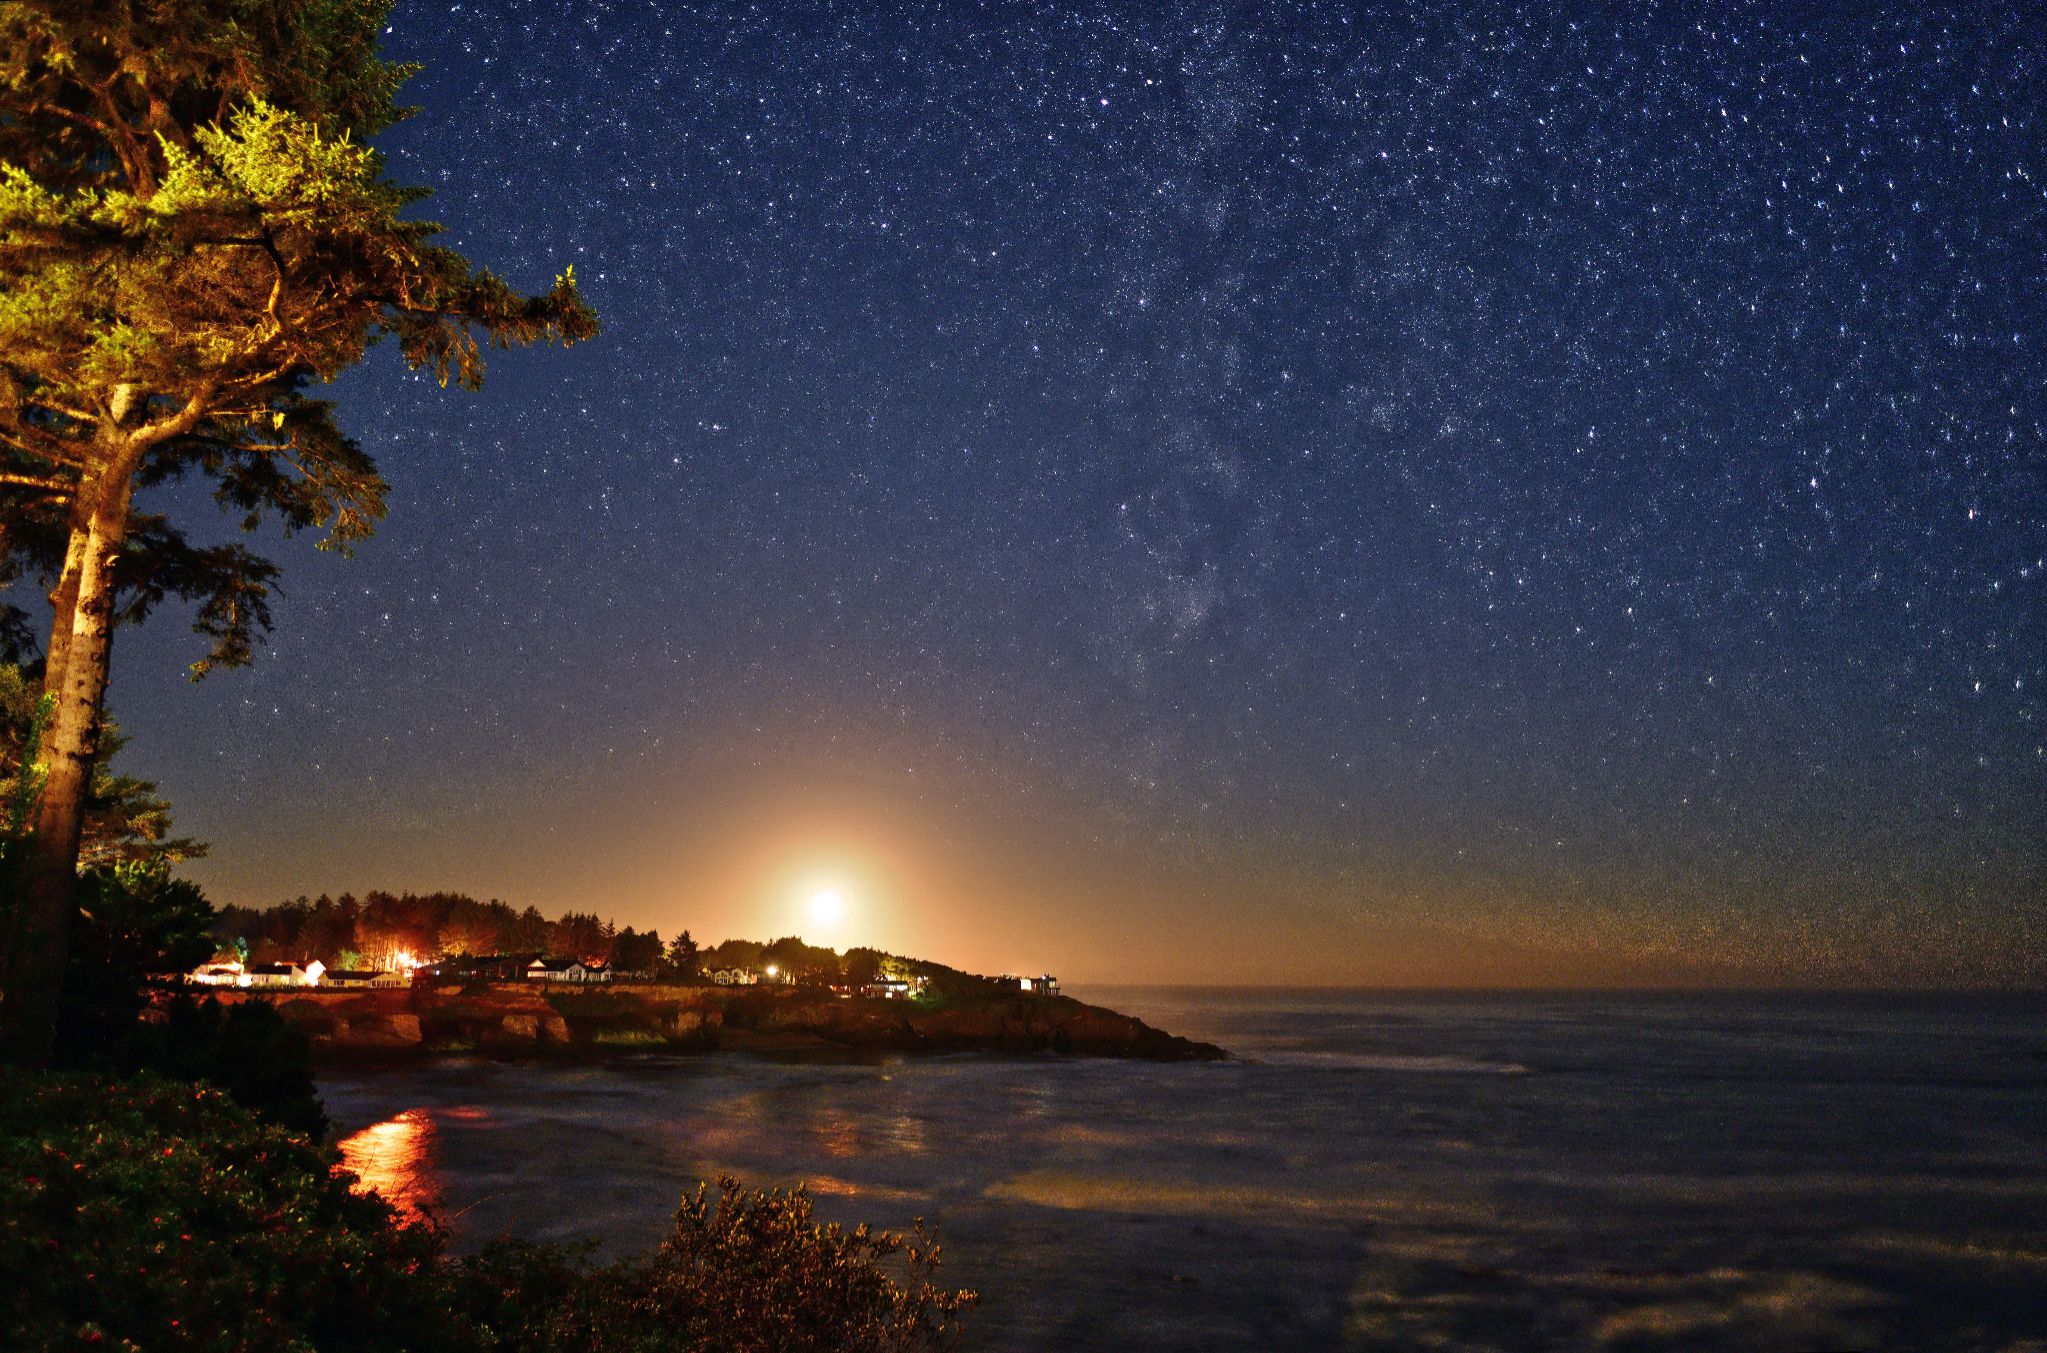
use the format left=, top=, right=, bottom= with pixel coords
left=0, top=0, right=596, bottom=1060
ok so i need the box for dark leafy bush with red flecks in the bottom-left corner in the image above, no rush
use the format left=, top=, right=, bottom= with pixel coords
left=0, top=1073, right=456, bottom=1349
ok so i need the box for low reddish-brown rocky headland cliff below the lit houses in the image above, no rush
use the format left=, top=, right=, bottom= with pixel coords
left=203, top=983, right=1228, bottom=1062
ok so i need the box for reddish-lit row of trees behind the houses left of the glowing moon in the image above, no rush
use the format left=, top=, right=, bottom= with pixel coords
left=213, top=890, right=671, bottom=972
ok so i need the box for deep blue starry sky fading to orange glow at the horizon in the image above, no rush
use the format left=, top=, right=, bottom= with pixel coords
left=111, top=0, right=2047, bottom=985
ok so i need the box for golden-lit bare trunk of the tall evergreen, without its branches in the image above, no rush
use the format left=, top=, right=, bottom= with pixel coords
left=0, top=464, right=133, bottom=1066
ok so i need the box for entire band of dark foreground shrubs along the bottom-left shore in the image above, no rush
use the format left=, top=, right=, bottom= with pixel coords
left=0, top=1073, right=972, bottom=1353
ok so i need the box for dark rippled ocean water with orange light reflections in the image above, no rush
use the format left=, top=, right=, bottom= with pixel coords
left=321, top=989, right=2047, bottom=1351
